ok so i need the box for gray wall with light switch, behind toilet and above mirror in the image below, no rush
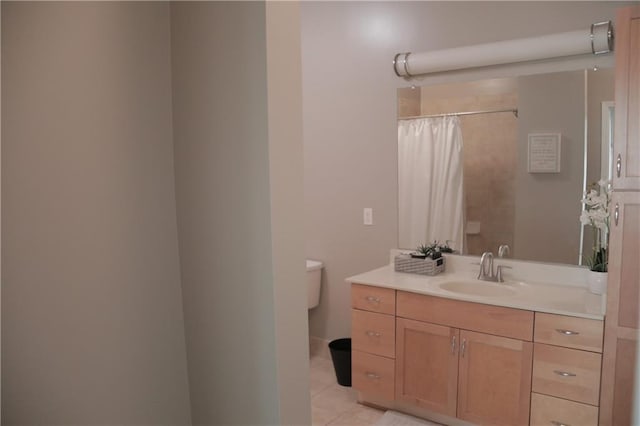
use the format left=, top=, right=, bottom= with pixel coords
left=301, top=1, right=622, bottom=339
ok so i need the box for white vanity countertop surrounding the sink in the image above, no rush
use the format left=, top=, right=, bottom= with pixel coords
left=346, top=257, right=606, bottom=320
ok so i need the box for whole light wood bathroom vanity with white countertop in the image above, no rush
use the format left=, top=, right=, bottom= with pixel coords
left=347, top=256, right=604, bottom=426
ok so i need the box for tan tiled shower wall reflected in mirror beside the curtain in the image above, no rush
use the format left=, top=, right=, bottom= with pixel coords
left=398, top=79, right=518, bottom=255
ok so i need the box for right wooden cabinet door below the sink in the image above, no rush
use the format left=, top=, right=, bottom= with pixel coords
left=458, top=330, right=533, bottom=425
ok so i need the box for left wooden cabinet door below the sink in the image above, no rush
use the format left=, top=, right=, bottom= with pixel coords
left=396, top=318, right=460, bottom=417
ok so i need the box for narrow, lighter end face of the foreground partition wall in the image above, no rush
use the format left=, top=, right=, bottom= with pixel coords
left=266, top=2, right=311, bottom=425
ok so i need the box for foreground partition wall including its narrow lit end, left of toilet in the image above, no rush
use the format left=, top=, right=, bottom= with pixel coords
left=171, top=2, right=310, bottom=424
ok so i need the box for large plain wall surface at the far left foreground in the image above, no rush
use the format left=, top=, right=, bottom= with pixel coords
left=2, top=2, right=190, bottom=425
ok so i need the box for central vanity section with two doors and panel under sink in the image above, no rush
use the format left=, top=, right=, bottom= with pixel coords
left=396, top=291, right=533, bottom=425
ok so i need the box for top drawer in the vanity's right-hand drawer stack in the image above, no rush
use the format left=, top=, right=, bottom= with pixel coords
left=533, top=312, right=604, bottom=352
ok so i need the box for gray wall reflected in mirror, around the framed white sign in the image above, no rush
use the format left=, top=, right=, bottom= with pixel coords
left=513, top=71, right=585, bottom=264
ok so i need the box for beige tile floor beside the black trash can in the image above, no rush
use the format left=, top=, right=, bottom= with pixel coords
left=309, top=356, right=384, bottom=426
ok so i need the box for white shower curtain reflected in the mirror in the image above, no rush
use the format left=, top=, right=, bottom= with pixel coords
left=398, top=117, right=465, bottom=253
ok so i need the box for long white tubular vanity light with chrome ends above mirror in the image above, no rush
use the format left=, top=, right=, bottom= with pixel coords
left=393, top=21, right=613, bottom=77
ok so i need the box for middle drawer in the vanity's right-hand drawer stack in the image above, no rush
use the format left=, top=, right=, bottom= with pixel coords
left=532, top=343, right=602, bottom=405
